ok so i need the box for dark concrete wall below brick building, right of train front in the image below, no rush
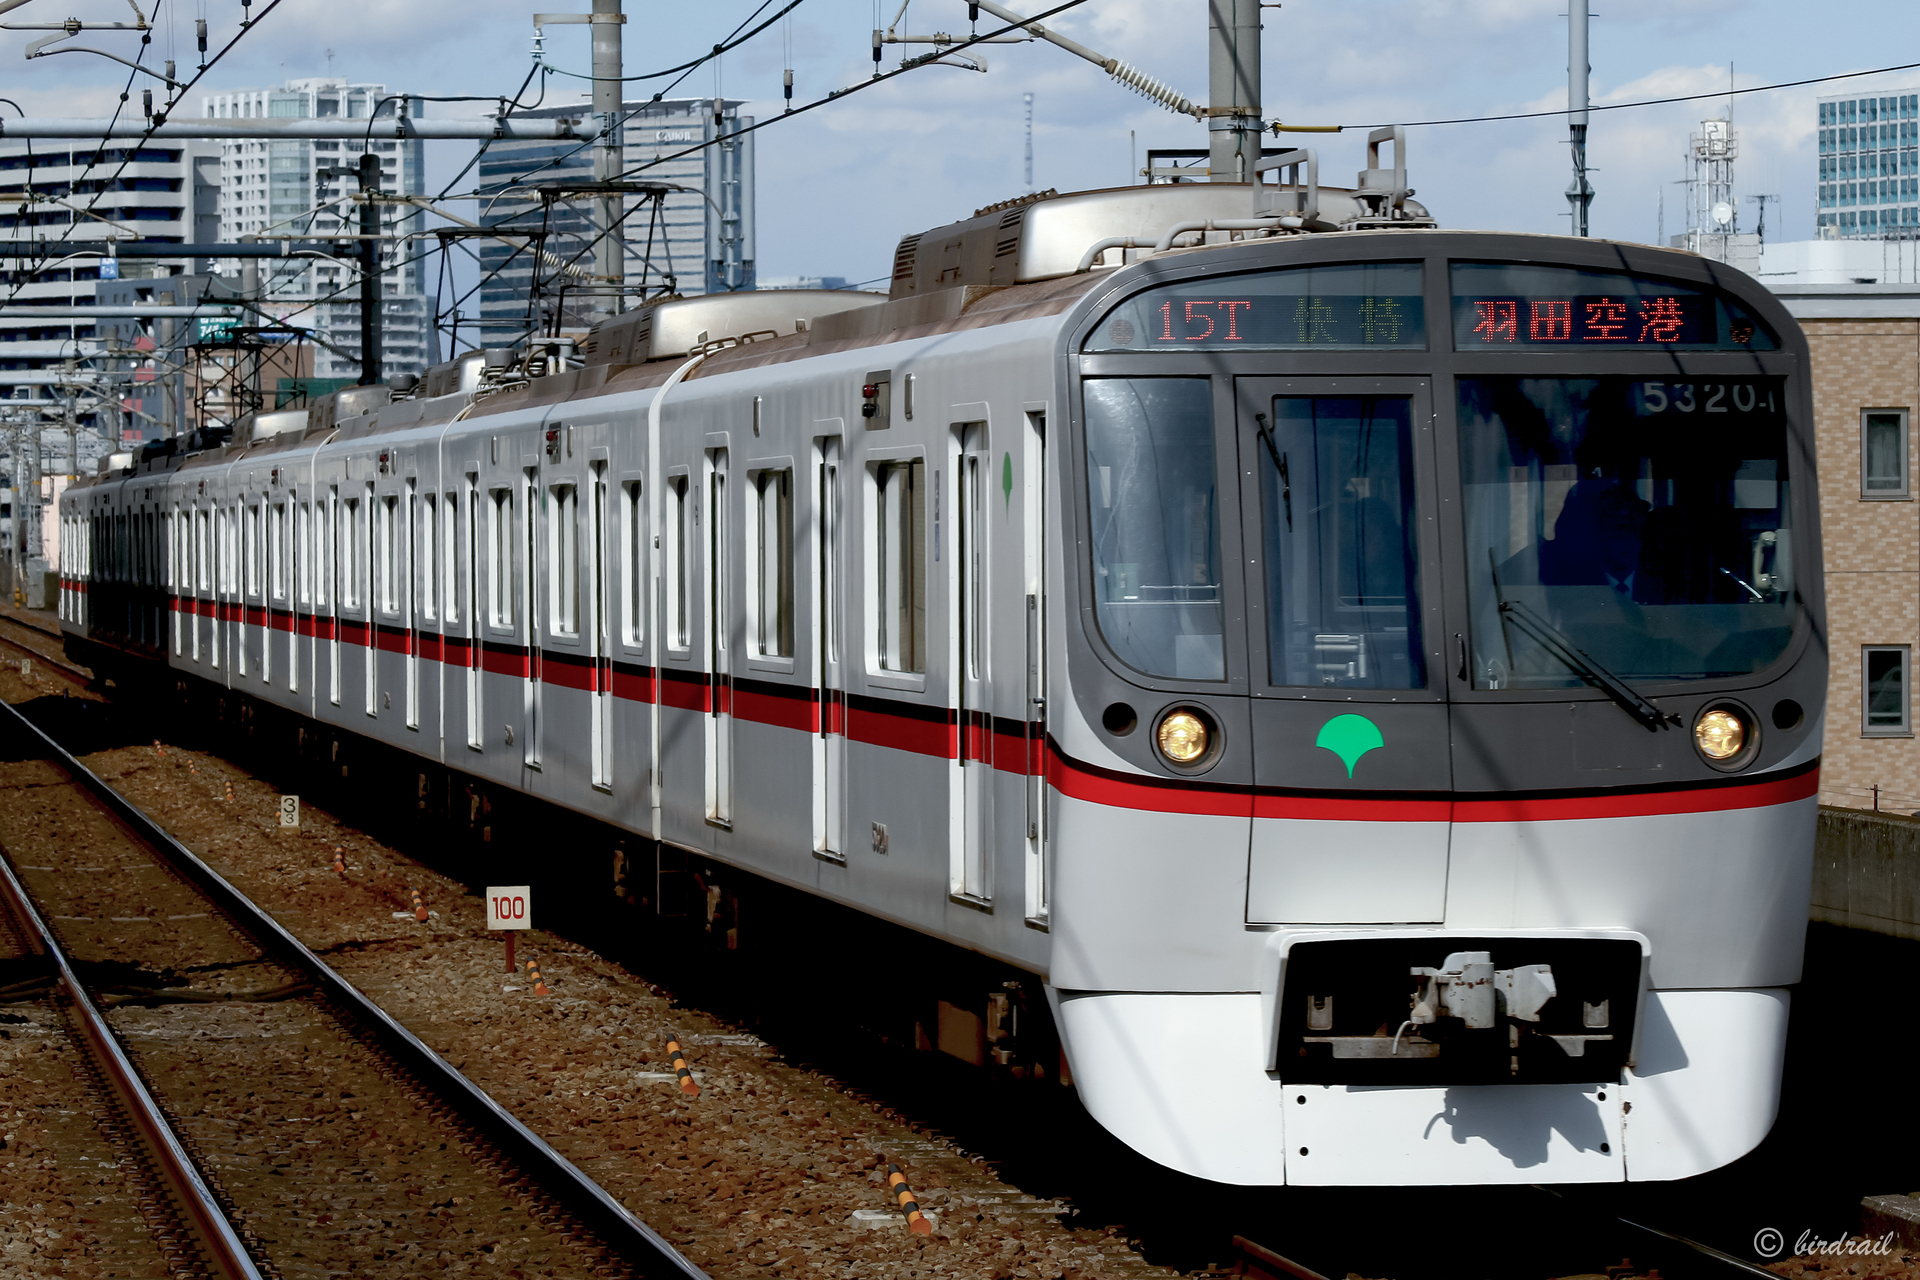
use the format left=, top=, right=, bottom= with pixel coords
left=1812, top=806, right=1920, bottom=938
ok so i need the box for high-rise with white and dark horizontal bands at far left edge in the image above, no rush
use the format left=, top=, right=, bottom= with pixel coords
left=0, top=138, right=219, bottom=449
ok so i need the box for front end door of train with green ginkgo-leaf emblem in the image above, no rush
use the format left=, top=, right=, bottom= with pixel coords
left=1235, top=378, right=1452, bottom=923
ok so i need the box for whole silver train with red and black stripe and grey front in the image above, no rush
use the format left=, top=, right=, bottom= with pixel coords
left=61, top=157, right=1826, bottom=1184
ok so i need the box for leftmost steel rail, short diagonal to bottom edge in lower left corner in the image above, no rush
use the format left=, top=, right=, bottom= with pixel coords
left=0, top=825, right=261, bottom=1280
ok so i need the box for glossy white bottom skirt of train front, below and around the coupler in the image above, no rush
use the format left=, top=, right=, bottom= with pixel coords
left=1052, top=990, right=1788, bottom=1186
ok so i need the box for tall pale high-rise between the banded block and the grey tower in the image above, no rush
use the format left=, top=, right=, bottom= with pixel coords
left=202, top=77, right=438, bottom=378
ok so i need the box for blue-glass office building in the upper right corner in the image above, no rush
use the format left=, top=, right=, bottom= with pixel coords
left=1818, top=90, right=1920, bottom=240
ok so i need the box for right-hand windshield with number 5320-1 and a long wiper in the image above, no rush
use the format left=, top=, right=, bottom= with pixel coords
left=1457, top=376, right=1801, bottom=689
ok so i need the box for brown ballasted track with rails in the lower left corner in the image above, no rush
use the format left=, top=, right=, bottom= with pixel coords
left=0, top=708, right=703, bottom=1280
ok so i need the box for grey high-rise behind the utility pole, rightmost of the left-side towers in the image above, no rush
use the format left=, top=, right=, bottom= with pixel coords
left=474, top=98, right=755, bottom=344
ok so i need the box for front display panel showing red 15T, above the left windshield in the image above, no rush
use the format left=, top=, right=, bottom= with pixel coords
left=1083, top=263, right=1427, bottom=351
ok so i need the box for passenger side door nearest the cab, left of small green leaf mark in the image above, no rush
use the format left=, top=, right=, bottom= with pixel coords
left=948, top=422, right=995, bottom=906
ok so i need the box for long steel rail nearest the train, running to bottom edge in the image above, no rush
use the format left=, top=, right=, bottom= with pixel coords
left=0, top=704, right=708, bottom=1280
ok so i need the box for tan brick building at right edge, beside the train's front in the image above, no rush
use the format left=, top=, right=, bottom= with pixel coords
left=1772, top=284, right=1920, bottom=814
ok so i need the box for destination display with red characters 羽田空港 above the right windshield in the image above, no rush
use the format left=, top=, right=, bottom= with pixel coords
left=1453, top=263, right=1778, bottom=351
